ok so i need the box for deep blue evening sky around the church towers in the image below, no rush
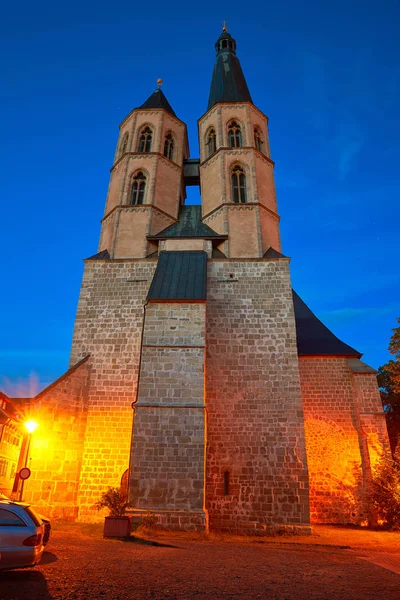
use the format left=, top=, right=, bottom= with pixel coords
left=0, top=0, right=400, bottom=395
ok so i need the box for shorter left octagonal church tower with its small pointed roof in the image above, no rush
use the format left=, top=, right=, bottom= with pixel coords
left=98, top=79, right=189, bottom=260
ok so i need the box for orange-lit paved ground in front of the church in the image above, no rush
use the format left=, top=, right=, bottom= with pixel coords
left=0, top=524, right=400, bottom=600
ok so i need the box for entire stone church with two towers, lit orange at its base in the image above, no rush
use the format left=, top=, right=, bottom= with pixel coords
left=3, top=28, right=388, bottom=533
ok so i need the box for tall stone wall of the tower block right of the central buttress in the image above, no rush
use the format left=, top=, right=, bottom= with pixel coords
left=206, top=259, right=309, bottom=531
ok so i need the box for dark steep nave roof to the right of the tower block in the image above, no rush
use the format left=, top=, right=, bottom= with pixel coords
left=293, top=290, right=362, bottom=358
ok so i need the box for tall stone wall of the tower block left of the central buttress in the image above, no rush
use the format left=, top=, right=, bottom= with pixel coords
left=71, top=259, right=156, bottom=521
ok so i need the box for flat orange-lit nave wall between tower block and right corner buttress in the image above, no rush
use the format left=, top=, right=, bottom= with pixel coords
left=299, top=357, right=383, bottom=523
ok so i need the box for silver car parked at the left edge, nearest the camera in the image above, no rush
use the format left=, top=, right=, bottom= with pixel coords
left=0, top=500, right=44, bottom=571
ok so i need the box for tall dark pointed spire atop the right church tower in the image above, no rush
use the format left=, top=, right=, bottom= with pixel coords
left=207, top=25, right=252, bottom=110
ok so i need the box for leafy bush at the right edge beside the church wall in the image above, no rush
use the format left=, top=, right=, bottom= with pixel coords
left=372, top=451, right=400, bottom=529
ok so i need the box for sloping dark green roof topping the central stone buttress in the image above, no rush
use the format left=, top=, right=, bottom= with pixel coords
left=147, top=250, right=207, bottom=301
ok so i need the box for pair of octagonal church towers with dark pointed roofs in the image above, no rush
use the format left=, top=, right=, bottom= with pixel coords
left=100, top=31, right=280, bottom=259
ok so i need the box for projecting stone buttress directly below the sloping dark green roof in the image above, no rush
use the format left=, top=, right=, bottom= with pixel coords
left=130, top=302, right=206, bottom=528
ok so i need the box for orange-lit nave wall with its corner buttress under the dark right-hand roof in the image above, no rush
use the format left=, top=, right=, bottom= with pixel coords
left=299, top=357, right=388, bottom=523
